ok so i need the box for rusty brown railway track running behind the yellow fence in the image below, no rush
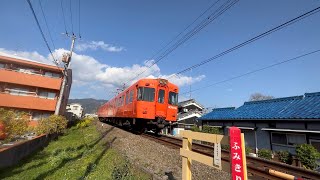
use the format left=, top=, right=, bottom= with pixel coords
left=141, top=134, right=320, bottom=180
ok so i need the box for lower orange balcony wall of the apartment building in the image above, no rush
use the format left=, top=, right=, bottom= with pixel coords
left=0, top=93, right=57, bottom=111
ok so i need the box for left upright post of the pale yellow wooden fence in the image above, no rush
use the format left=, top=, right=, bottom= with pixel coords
left=182, top=138, right=192, bottom=180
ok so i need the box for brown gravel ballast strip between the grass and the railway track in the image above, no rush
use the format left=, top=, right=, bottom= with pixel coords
left=97, top=122, right=230, bottom=180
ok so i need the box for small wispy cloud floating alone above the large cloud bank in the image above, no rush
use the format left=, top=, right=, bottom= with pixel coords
left=75, top=41, right=125, bottom=52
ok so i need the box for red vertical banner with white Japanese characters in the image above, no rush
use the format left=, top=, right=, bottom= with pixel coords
left=229, top=127, right=244, bottom=180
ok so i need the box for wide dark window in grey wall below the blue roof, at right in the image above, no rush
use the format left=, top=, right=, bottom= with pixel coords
left=271, top=132, right=307, bottom=146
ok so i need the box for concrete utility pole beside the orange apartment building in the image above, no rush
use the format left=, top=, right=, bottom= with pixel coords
left=54, top=34, right=76, bottom=115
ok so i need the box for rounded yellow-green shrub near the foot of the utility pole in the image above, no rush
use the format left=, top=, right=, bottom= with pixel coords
left=36, top=115, right=67, bottom=135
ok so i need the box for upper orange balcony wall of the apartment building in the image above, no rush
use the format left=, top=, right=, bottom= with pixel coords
left=0, top=69, right=62, bottom=90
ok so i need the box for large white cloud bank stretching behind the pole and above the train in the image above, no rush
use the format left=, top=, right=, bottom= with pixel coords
left=0, top=48, right=205, bottom=97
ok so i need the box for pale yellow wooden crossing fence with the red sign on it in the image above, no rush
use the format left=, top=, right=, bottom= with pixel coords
left=180, top=127, right=247, bottom=180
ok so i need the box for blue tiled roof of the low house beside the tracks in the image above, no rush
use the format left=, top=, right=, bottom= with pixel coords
left=199, top=92, right=320, bottom=120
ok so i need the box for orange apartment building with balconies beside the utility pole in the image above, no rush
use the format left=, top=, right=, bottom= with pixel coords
left=0, top=55, right=72, bottom=121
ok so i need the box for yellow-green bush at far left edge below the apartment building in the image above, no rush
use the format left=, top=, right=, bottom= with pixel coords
left=0, top=108, right=29, bottom=141
